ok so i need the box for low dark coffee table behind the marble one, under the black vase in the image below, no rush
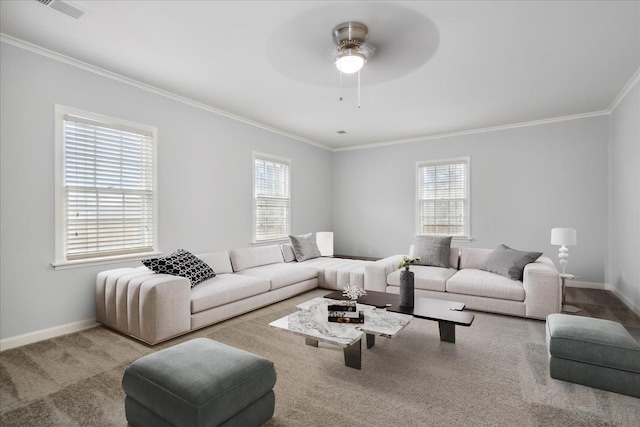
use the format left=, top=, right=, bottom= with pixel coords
left=325, top=291, right=475, bottom=343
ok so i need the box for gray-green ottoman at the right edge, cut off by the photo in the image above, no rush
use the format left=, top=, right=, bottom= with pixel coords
left=547, top=314, right=640, bottom=397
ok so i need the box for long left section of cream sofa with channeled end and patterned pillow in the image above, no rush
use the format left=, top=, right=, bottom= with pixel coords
left=96, top=244, right=373, bottom=344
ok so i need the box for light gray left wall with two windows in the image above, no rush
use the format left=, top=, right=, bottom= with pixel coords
left=0, top=44, right=333, bottom=339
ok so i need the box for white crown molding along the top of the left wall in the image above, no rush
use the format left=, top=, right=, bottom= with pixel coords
left=0, top=33, right=333, bottom=151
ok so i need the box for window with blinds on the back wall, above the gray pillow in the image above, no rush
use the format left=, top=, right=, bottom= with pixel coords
left=417, top=157, right=471, bottom=239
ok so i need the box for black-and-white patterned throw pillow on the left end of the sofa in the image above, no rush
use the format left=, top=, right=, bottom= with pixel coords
left=142, top=249, right=216, bottom=288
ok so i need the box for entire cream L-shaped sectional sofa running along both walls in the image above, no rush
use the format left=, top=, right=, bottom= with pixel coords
left=96, top=244, right=562, bottom=345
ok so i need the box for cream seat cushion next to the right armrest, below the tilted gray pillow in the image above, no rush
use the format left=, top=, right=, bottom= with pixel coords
left=446, top=268, right=524, bottom=301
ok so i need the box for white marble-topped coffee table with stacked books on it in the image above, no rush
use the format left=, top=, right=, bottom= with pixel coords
left=269, top=294, right=412, bottom=369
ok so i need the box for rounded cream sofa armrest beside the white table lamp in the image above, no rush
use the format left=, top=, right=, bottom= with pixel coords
left=522, top=257, right=562, bottom=319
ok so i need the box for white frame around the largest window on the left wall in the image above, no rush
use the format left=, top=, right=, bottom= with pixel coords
left=51, top=104, right=160, bottom=270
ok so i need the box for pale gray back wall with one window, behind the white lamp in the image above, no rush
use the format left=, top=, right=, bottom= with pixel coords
left=334, top=116, right=608, bottom=283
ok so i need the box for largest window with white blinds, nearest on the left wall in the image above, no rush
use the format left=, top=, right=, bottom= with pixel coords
left=54, top=106, right=157, bottom=267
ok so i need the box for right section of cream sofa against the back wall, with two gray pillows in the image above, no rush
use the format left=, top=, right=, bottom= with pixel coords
left=365, top=247, right=562, bottom=320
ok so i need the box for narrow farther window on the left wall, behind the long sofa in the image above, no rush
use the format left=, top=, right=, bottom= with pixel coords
left=253, top=153, right=291, bottom=242
